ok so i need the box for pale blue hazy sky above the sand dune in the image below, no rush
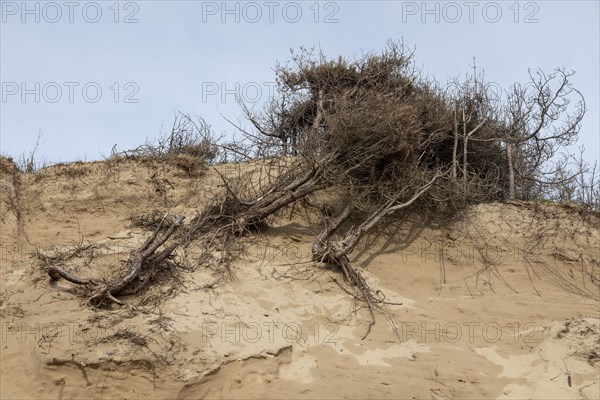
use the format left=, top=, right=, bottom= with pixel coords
left=0, top=0, right=600, bottom=167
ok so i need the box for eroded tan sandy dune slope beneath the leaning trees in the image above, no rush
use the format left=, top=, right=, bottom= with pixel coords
left=0, top=160, right=600, bottom=399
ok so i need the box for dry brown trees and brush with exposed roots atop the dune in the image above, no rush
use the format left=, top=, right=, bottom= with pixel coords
left=3, top=43, right=600, bottom=338
